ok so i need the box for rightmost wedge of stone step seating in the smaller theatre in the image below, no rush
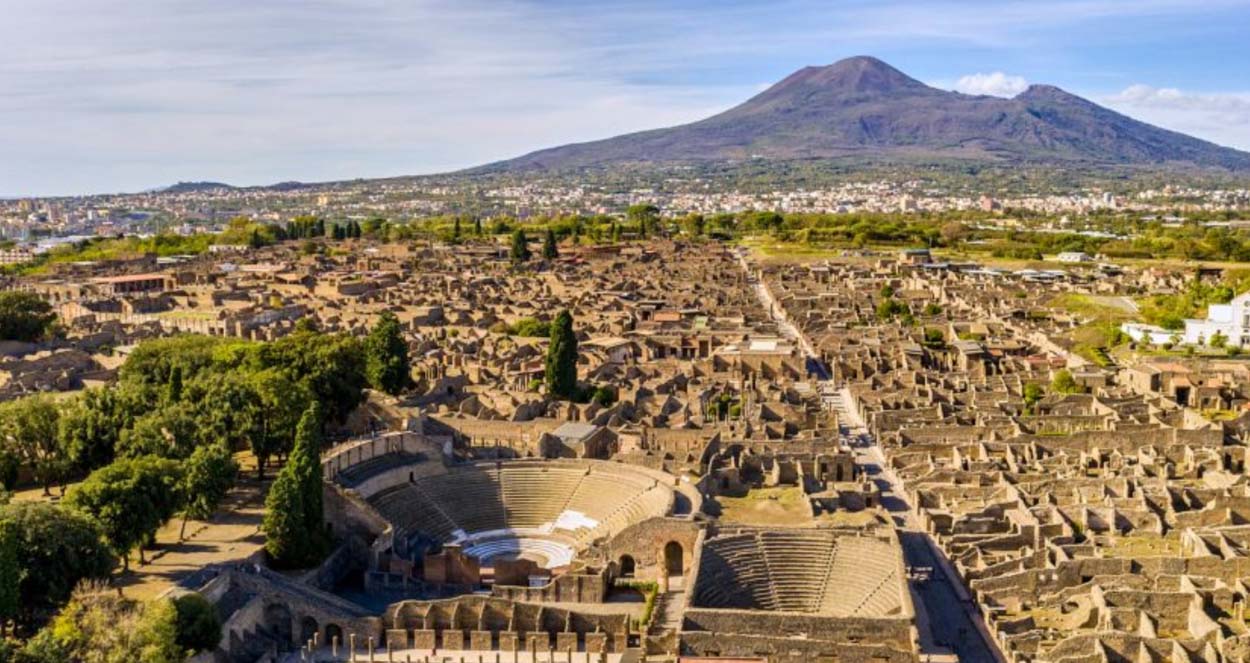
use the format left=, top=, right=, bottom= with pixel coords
left=823, top=538, right=903, bottom=615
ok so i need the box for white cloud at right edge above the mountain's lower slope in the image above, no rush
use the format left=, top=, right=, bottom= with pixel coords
left=1099, top=84, right=1250, bottom=150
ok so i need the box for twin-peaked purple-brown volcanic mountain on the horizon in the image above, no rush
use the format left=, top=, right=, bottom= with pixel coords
left=476, top=56, right=1250, bottom=173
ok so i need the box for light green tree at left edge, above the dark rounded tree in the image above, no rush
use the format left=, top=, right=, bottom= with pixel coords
left=0, top=394, right=69, bottom=495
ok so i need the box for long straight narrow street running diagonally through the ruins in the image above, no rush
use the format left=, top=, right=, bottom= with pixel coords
left=738, top=250, right=1005, bottom=663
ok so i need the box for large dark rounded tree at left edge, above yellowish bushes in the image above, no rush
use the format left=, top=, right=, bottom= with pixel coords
left=0, top=502, right=115, bottom=625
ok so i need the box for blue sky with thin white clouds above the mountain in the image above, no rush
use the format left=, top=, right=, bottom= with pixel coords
left=0, top=0, right=1250, bottom=195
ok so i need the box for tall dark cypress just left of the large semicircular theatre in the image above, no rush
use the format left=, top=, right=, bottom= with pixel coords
left=261, top=402, right=326, bottom=568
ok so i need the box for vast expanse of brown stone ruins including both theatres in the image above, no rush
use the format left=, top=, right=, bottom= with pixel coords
left=7, top=239, right=1250, bottom=663
